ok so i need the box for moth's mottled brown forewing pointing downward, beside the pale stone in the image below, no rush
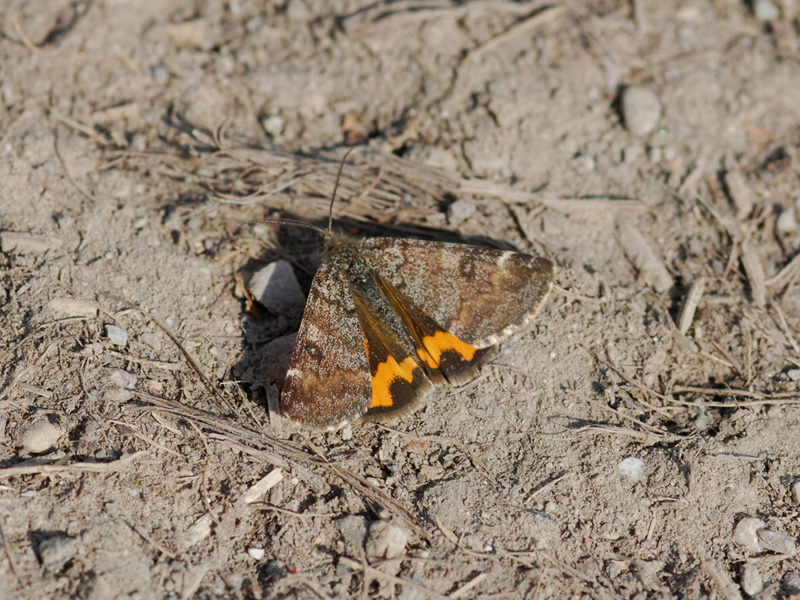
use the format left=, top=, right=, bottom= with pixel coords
left=281, top=263, right=372, bottom=429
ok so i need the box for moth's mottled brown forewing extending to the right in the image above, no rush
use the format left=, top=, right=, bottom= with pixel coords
left=360, top=238, right=553, bottom=348
